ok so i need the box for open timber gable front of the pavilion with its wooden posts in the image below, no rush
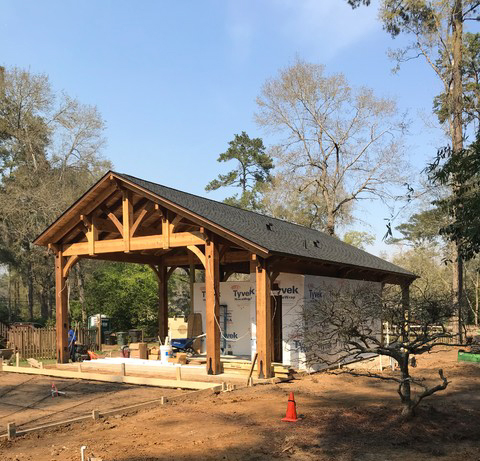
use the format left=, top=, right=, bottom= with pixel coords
left=39, top=174, right=272, bottom=377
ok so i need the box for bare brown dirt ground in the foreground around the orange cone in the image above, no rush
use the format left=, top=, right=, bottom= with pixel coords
left=0, top=350, right=480, bottom=461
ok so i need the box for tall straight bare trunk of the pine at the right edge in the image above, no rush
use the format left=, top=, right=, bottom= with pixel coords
left=452, top=0, right=463, bottom=342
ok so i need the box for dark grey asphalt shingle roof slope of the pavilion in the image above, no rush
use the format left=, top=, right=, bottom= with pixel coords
left=115, top=173, right=414, bottom=277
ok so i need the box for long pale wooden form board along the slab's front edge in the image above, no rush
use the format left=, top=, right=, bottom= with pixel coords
left=3, top=365, right=222, bottom=390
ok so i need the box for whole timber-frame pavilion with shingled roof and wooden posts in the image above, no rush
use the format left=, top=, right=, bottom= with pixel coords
left=34, top=171, right=416, bottom=378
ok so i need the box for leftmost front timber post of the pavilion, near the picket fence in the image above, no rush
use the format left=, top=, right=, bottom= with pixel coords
left=55, top=250, right=69, bottom=363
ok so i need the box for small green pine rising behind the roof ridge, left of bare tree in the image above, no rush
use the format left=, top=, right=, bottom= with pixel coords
left=205, top=131, right=273, bottom=210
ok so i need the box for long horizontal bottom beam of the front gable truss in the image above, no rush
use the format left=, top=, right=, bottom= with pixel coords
left=62, top=232, right=205, bottom=256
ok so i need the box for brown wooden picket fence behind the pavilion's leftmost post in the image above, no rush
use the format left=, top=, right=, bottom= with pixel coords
left=7, top=326, right=99, bottom=360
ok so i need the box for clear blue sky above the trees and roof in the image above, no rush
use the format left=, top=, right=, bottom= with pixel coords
left=0, top=0, right=462, bottom=254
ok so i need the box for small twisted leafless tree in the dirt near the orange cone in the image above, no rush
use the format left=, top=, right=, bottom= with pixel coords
left=302, top=286, right=454, bottom=417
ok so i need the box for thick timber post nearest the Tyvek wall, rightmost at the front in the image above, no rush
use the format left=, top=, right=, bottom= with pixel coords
left=255, top=258, right=273, bottom=378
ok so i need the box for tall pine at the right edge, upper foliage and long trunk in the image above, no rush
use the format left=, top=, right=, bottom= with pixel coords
left=380, top=0, right=480, bottom=344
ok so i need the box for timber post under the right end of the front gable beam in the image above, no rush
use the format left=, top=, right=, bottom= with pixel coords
left=205, top=236, right=221, bottom=375
